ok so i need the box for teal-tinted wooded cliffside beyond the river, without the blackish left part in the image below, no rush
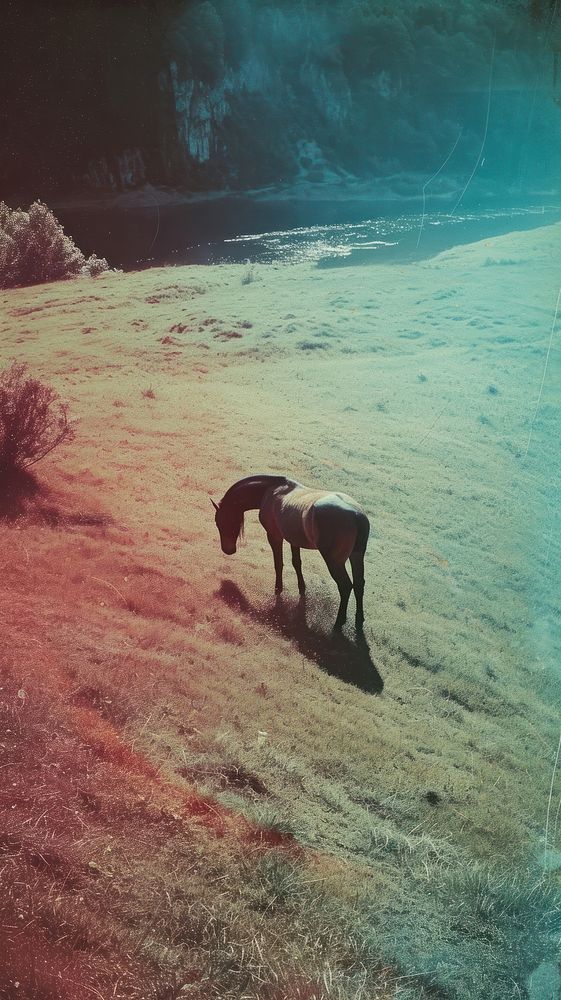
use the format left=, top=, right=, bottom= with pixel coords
left=159, top=0, right=558, bottom=193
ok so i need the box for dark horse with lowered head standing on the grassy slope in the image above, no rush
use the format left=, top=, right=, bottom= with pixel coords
left=211, top=475, right=370, bottom=631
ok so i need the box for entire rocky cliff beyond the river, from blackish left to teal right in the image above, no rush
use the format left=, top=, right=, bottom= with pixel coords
left=0, top=0, right=561, bottom=195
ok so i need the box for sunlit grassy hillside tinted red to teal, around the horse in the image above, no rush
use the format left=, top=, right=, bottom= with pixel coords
left=0, top=227, right=561, bottom=1000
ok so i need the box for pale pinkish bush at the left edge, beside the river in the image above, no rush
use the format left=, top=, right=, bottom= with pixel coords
left=0, top=201, right=109, bottom=288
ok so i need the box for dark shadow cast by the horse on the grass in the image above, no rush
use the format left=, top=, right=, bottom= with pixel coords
left=216, top=580, right=384, bottom=694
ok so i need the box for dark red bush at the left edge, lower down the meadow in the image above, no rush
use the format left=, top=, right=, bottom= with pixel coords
left=0, top=362, right=74, bottom=476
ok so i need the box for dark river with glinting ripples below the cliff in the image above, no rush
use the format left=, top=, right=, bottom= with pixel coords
left=57, top=196, right=561, bottom=271
